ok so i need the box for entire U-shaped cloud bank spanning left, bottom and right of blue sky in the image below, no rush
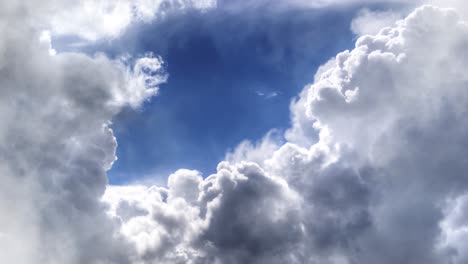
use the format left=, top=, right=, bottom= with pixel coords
left=0, top=0, right=468, bottom=264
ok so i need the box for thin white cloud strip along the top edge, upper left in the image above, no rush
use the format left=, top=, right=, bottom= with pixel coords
left=39, top=0, right=216, bottom=41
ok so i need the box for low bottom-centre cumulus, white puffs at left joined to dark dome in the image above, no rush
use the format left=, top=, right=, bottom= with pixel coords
left=104, top=163, right=302, bottom=263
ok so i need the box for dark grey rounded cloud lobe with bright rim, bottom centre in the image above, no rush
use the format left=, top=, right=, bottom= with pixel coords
left=197, top=163, right=302, bottom=263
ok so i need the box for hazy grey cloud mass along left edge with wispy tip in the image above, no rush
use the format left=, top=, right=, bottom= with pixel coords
left=0, top=1, right=166, bottom=264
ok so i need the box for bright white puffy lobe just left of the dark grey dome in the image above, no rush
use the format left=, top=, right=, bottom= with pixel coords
left=103, top=183, right=203, bottom=263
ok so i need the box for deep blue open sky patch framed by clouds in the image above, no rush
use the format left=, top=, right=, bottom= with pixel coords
left=55, top=3, right=398, bottom=184
